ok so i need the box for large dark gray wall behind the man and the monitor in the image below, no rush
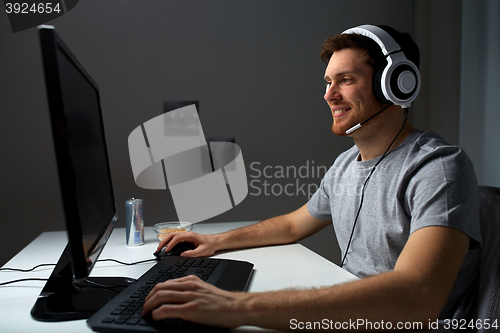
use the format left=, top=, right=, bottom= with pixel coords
left=0, top=0, right=460, bottom=264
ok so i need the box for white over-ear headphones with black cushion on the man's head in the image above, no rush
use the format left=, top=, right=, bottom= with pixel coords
left=342, top=24, right=420, bottom=108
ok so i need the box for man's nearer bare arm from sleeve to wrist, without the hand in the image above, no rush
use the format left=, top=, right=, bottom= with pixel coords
left=236, top=226, right=469, bottom=329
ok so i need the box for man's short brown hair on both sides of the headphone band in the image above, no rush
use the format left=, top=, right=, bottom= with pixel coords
left=320, top=25, right=420, bottom=70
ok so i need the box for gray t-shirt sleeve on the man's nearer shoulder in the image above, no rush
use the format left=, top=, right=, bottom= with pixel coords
left=405, top=146, right=481, bottom=249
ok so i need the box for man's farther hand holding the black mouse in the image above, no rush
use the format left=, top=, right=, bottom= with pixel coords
left=157, top=231, right=217, bottom=257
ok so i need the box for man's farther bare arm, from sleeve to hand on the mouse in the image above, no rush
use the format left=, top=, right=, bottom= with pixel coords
left=158, top=204, right=331, bottom=257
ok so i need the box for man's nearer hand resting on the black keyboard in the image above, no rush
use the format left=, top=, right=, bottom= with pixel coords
left=142, top=275, right=246, bottom=327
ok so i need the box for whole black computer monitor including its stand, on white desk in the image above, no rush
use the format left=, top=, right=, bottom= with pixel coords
left=31, top=26, right=133, bottom=321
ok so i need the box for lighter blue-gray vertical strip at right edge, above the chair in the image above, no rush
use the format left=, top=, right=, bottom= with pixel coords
left=460, top=0, right=500, bottom=187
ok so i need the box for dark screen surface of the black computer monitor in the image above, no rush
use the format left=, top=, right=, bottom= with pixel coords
left=57, top=43, right=115, bottom=262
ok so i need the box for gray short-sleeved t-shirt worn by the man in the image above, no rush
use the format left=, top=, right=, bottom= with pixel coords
left=307, top=130, right=481, bottom=319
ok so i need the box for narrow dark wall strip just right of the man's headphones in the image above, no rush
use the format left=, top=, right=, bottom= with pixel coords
left=412, top=0, right=462, bottom=144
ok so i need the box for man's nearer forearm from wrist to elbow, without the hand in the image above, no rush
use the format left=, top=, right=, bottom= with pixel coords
left=236, top=272, right=443, bottom=330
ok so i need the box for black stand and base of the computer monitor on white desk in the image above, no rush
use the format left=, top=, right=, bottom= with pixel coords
left=31, top=244, right=135, bottom=321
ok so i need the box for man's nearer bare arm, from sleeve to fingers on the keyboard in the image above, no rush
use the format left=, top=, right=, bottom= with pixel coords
left=144, top=227, right=469, bottom=329
